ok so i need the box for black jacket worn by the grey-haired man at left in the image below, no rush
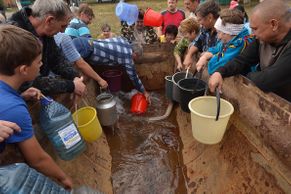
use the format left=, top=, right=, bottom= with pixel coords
left=8, top=8, right=79, bottom=94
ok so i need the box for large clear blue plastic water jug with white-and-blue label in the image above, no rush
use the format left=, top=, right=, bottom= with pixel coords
left=40, top=98, right=86, bottom=160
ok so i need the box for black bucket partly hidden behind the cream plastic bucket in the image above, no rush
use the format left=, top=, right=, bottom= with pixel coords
left=178, top=78, right=207, bottom=112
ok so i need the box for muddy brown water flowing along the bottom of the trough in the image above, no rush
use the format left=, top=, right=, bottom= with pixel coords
left=104, top=92, right=187, bottom=194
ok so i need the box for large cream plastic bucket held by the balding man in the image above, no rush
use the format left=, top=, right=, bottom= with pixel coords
left=188, top=96, right=234, bottom=144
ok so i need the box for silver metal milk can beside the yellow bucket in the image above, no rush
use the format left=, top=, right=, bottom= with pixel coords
left=96, top=93, right=118, bottom=126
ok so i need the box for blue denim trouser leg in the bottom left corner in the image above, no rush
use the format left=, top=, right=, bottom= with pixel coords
left=0, top=163, right=70, bottom=194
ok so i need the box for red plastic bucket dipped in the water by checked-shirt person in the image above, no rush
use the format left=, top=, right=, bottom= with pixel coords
left=130, top=93, right=148, bottom=114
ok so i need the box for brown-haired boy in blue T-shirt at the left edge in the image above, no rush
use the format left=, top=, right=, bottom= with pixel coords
left=0, top=25, right=73, bottom=189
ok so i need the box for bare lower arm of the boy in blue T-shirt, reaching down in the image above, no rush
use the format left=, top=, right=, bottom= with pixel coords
left=18, top=136, right=73, bottom=190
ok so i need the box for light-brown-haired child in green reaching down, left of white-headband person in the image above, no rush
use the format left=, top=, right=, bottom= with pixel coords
left=174, top=17, right=200, bottom=70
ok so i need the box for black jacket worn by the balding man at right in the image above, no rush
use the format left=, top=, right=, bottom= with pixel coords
left=217, top=30, right=291, bottom=102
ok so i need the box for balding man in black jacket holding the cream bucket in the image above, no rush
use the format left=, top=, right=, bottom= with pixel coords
left=209, top=0, right=291, bottom=101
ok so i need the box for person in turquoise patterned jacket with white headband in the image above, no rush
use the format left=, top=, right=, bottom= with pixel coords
left=196, top=9, right=253, bottom=75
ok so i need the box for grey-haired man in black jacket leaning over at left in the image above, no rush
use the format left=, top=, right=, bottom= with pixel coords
left=8, top=0, right=86, bottom=95
